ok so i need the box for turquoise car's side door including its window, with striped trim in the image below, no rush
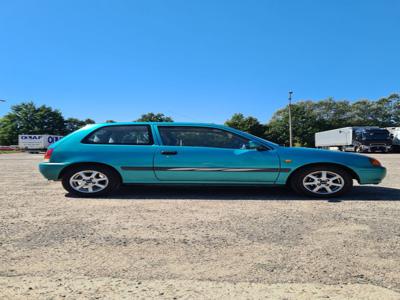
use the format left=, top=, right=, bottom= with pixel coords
left=154, top=125, right=280, bottom=183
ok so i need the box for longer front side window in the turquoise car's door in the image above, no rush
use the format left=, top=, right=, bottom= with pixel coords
left=158, top=126, right=249, bottom=149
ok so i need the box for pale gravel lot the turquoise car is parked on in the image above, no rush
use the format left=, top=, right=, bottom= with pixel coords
left=0, top=154, right=400, bottom=299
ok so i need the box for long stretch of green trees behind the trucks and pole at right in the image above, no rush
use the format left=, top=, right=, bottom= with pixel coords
left=266, top=94, right=400, bottom=147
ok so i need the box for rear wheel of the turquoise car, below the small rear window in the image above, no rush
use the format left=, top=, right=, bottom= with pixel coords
left=62, top=164, right=121, bottom=197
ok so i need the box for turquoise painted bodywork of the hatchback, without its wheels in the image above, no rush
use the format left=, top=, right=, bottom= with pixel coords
left=39, top=122, right=386, bottom=197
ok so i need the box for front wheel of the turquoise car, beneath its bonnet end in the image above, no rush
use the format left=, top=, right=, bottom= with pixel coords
left=290, top=165, right=353, bottom=198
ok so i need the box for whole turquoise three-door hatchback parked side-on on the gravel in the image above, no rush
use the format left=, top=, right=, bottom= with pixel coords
left=39, top=122, right=386, bottom=197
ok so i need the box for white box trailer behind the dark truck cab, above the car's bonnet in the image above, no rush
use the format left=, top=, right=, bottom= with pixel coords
left=315, top=127, right=354, bottom=151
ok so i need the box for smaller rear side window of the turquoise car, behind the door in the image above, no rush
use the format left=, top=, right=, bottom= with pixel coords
left=82, top=125, right=153, bottom=145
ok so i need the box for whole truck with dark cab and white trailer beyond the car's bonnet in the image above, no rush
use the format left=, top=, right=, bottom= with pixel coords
left=315, top=127, right=392, bottom=152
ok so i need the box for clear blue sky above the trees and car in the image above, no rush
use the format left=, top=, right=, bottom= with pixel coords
left=0, top=0, right=400, bottom=123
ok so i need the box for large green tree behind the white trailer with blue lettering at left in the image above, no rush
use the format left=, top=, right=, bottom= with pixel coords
left=0, top=102, right=65, bottom=145
